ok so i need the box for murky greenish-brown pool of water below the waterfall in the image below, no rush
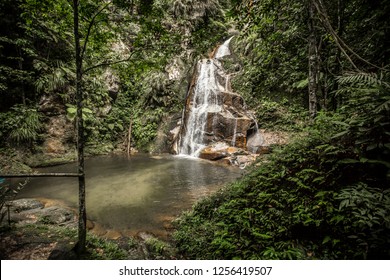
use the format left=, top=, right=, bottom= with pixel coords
left=18, top=155, right=241, bottom=237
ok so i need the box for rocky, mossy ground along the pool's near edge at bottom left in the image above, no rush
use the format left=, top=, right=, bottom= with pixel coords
left=0, top=199, right=177, bottom=260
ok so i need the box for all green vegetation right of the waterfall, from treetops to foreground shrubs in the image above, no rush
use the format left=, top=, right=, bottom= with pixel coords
left=175, top=0, right=390, bottom=259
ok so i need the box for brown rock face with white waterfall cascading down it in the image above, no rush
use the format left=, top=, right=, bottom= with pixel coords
left=176, top=38, right=262, bottom=159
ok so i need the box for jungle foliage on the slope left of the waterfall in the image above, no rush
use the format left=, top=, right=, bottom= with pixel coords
left=0, top=0, right=227, bottom=151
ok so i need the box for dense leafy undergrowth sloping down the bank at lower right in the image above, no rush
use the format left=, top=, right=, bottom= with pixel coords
left=174, top=72, right=390, bottom=259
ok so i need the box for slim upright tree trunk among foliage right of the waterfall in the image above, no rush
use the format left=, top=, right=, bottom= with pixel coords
left=308, top=0, right=319, bottom=119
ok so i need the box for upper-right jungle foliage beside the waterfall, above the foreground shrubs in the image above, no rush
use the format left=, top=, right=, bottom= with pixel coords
left=231, top=0, right=390, bottom=110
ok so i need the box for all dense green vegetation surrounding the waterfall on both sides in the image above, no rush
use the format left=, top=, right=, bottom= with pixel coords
left=0, top=0, right=390, bottom=259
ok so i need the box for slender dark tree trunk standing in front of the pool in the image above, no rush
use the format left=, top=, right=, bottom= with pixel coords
left=73, top=0, right=87, bottom=254
